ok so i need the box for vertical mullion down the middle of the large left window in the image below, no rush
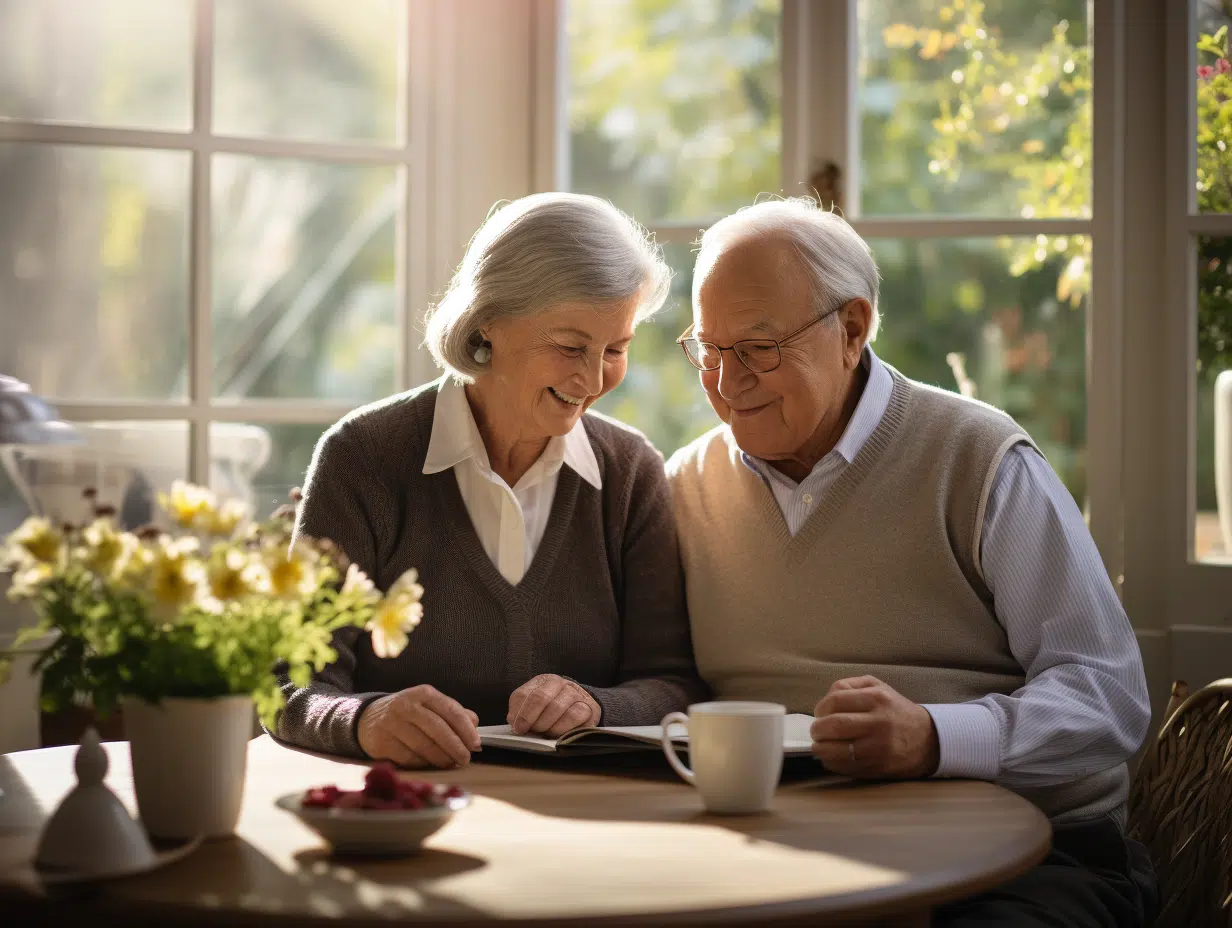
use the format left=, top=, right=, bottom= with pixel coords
left=188, top=0, right=214, bottom=484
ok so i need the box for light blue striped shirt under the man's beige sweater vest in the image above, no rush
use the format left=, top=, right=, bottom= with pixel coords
left=744, top=349, right=1151, bottom=786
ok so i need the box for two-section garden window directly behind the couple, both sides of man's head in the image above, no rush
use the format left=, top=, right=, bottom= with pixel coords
left=558, top=0, right=1092, bottom=500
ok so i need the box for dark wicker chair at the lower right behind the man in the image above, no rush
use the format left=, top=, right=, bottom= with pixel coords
left=1129, top=679, right=1232, bottom=928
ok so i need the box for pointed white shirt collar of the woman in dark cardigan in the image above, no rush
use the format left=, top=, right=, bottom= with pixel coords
left=424, top=377, right=604, bottom=489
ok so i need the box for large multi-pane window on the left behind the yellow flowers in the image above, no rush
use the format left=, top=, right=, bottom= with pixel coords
left=0, top=0, right=418, bottom=521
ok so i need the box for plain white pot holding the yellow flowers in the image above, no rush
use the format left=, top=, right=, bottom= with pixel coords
left=123, top=696, right=253, bottom=840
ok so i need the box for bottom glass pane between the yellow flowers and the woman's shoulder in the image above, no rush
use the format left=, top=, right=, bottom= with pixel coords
left=209, top=423, right=329, bottom=519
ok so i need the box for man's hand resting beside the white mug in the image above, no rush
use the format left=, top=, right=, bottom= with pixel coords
left=809, top=677, right=941, bottom=779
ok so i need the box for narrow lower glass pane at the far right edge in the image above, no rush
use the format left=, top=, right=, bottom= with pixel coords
left=1194, top=235, right=1232, bottom=563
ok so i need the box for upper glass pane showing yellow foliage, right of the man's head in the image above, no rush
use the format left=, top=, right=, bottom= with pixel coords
left=859, top=0, right=1092, bottom=217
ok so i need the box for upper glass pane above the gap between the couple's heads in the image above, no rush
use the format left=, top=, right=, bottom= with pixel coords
left=565, top=0, right=781, bottom=222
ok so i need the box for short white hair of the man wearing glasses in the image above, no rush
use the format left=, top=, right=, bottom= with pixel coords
left=694, top=197, right=881, bottom=341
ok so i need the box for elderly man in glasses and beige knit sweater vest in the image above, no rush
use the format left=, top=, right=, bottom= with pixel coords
left=668, top=201, right=1153, bottom=926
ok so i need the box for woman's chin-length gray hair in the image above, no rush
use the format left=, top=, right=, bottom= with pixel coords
left=425, top=193, right=671, bottom=381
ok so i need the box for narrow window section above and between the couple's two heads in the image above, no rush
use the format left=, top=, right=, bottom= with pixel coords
left=557, top=0, right=782, bottom=454
